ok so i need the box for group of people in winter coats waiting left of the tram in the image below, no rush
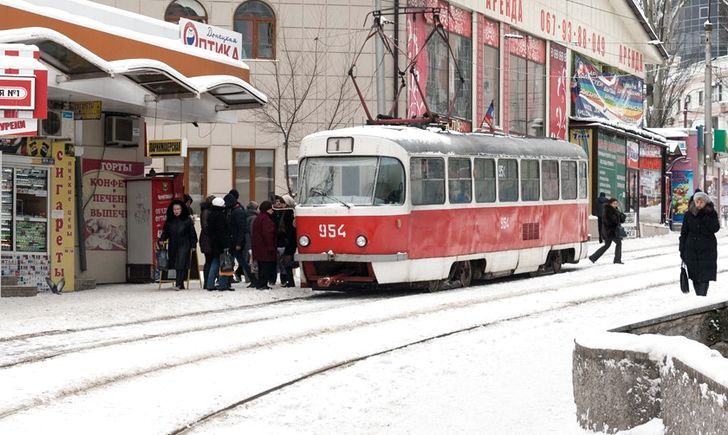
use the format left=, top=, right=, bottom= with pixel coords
left=157, top=189, right=298, bottom=291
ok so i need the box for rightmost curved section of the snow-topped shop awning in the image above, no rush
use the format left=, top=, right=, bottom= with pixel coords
left=190, top=76, right=268, bottom=111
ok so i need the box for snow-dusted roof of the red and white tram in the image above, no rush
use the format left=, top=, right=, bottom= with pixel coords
left=304, top=126, right=586, bottom=159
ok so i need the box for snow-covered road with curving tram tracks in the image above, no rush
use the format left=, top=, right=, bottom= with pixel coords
left=0, top=234, right=728, bottom=434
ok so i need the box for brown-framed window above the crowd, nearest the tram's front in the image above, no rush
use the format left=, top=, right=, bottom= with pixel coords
left=233, top=150, right=275, bottom=204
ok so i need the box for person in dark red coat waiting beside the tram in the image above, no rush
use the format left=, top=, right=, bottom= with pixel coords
left=252, top=201, right=278, bottom=290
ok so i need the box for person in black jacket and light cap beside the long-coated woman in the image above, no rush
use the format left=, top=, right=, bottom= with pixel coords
left=205, top=198, right=233, bottom=290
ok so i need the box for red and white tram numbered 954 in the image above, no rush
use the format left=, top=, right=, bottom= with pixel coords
left=296, top=126, right=588, bottom=290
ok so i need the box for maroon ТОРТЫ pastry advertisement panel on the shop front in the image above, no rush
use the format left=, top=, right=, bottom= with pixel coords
left=83, top=159, right=144, bottom=251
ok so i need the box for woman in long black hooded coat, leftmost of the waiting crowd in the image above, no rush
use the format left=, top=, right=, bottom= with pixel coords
left=159, top=199, right=197, bottom=290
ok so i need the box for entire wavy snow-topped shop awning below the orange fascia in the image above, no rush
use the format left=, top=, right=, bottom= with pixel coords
left=0, top=27, right=267, bottom=123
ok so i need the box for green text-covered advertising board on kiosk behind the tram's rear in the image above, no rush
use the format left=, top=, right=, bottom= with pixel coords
left=597, top=131, right=627, bottom=209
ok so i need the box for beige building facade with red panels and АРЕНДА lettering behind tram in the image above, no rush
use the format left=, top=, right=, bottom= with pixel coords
left=99, top=0, right=666, bottom=218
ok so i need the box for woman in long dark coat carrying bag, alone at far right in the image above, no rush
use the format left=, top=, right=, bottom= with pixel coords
left=680, top=192, right=720, bottom=296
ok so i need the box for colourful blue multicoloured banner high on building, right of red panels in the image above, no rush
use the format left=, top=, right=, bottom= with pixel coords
left=572, top=54, right=644, bottom=126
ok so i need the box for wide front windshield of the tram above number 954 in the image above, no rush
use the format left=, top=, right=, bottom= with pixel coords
left=299, top=156, right=405, bottom=206
